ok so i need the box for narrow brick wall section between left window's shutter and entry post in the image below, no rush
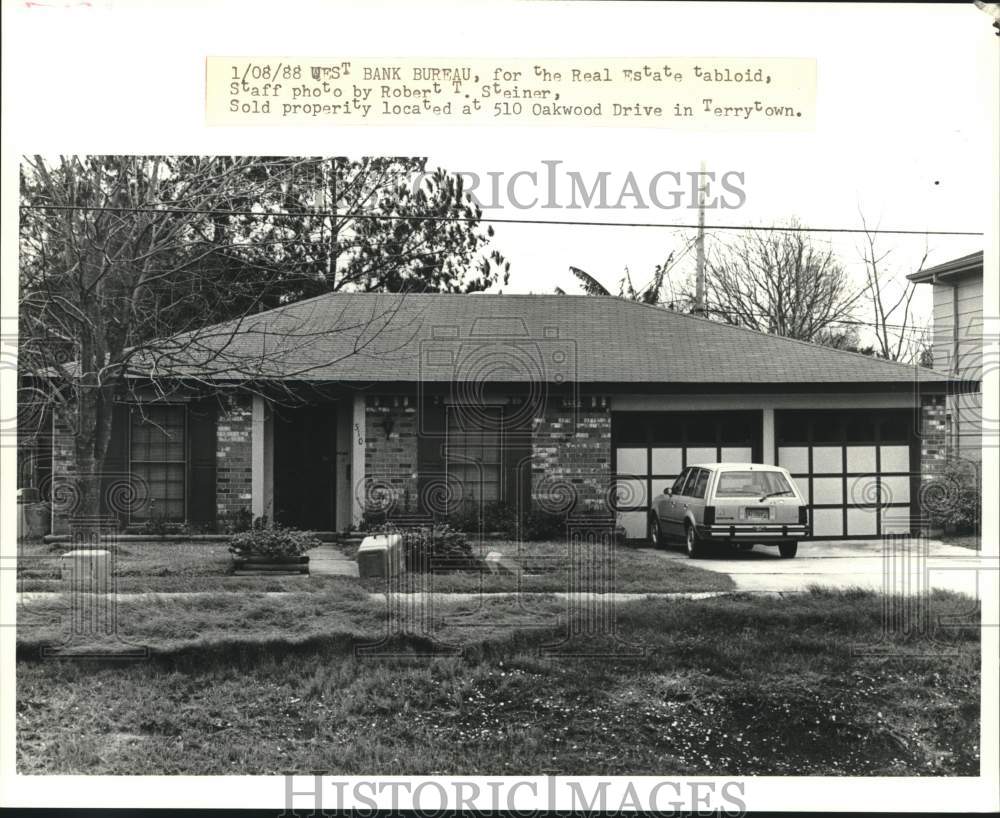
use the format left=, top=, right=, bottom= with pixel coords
left=215, top=395, right=253, bottom=528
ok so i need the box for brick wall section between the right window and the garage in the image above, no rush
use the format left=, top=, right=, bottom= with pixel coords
left=531, top=397, right=611, bottom=512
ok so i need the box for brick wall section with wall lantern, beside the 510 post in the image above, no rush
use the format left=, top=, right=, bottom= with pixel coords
left=363, top=395, right=417, bottom=515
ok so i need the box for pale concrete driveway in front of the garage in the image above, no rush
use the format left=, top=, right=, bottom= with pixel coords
left=653, top=540, right=984, bottom=597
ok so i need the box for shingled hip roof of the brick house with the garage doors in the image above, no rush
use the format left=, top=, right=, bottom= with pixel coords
left=140, top=293, right=960, bottom=385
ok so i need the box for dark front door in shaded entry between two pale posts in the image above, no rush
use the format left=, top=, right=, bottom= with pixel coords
left=274, top=405, right=337, bottom=531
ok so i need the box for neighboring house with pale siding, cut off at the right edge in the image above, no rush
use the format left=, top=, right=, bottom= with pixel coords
left=907, top=251, right=983, bottom=463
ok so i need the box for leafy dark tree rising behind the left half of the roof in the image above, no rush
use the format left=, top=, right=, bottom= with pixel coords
left=195, top=157, right=510, bottom=306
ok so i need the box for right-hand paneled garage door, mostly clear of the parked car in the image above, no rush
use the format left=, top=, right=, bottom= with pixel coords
left=774, top=409, right=919, bottom=538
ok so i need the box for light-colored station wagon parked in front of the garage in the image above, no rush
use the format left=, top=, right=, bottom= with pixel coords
left=649, top=463, right=809, bottom=558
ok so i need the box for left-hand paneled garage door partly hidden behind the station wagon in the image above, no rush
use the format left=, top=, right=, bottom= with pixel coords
left=611, top=411, right=761, bottom=539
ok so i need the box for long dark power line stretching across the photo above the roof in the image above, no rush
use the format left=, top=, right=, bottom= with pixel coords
left=20, top=204, right=984, bottom=236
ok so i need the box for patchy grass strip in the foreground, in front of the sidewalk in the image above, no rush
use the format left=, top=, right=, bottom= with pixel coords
left=17, top=585, right=979, bottom=776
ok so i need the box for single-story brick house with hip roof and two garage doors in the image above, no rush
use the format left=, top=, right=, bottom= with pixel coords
left=52, top=294, right=976, bottom=538
